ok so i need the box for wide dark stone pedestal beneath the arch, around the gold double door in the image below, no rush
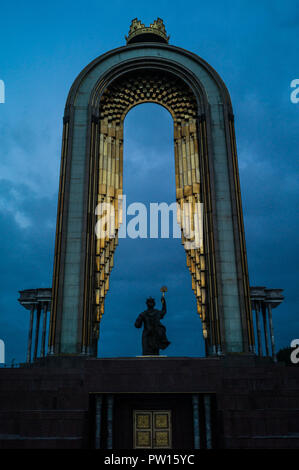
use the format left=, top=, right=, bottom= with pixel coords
left=0, top=355, right=299, bottom=449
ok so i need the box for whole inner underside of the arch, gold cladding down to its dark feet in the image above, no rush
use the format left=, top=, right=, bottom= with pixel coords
left=83, top=70, right=220, bottom=353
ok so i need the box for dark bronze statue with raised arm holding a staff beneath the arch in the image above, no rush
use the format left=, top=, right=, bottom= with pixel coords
left=135, top=292, right=170, bottom=356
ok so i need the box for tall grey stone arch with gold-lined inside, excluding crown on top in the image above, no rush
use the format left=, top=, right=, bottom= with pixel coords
left=49, top=18, right=254, bottom=355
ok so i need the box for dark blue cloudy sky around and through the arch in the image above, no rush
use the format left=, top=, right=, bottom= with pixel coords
left=0, top=0, right=299, bottom=363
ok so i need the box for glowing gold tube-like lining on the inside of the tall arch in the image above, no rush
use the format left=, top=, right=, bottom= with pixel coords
left=89, top=70, right=207, bottom=344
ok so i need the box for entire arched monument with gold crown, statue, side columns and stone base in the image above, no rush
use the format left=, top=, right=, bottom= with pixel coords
left=0, top=18, right=299, bottom=450
